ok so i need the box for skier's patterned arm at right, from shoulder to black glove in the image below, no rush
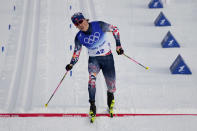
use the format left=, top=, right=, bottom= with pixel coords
left=99, top=21, right=124, bottom=55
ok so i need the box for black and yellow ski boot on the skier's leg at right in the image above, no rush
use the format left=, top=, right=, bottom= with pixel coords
left=107, top=92, right=115, bottom=118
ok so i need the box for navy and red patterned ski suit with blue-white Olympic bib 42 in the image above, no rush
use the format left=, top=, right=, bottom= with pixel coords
left=70, top=21, right=121, bottom=101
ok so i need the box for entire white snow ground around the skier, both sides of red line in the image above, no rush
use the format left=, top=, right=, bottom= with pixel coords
left=0, top=0, right=197, bottom=131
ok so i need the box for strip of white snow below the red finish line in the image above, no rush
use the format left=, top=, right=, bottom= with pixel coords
left=0, top=116, right=197, bottom=131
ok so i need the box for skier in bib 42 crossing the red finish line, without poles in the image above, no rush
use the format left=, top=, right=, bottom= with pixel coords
left=66, top=12, right=124, bottom=122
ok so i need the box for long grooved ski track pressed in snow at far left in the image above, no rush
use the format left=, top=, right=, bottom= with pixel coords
left=4, top=0, right=40, bottom=112
